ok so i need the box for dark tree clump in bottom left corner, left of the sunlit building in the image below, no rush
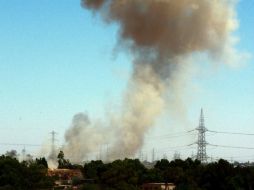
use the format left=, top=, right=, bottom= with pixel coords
left=0, top=155, right=53, bottom=190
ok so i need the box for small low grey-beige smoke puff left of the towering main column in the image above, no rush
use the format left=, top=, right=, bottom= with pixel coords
left=64, top=113, right=111, bottom=163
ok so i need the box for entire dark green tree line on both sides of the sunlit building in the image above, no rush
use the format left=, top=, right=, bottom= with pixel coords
left=0, top=151, right=254, bottom=190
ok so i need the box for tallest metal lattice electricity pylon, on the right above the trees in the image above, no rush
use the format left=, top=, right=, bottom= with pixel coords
left=196, top=109, right=207, bottom=163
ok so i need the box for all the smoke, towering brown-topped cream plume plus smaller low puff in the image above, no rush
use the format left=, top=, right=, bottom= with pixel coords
left=65, top=0, right=237, bottom=160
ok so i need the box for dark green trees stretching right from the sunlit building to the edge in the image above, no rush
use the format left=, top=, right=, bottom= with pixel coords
left=83, top=158, right=254, bottom=190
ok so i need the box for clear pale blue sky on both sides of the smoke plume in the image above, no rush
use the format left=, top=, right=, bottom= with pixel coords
left=0, top=0, right=254, bottom=161
